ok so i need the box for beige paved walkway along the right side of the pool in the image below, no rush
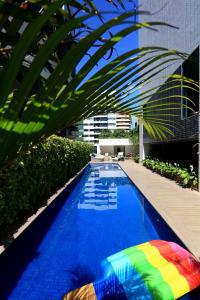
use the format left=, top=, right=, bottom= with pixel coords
left=120, top=160, right=200, bottom=260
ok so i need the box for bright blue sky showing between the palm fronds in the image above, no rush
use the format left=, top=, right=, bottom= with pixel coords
left=77, top=0, right=138, bottom=125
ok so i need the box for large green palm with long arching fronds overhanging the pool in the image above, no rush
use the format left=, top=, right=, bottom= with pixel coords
left=0, top=0, right=198, bottom=165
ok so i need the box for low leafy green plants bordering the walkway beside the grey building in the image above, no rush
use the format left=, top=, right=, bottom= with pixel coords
left=143, top=158, right=198, bottom=188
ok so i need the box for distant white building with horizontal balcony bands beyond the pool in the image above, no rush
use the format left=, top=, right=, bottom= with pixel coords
left=77, top=113, right=131, bottom=144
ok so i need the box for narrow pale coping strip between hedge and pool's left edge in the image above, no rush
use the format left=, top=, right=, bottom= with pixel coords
left=0, top=162, right=91, bottom=255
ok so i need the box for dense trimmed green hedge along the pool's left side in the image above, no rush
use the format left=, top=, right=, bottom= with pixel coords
left=0, top=136, right=93, bottom=231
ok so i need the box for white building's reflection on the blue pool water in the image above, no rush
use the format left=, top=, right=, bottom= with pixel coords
left=78, top=164, right=127, bottom=210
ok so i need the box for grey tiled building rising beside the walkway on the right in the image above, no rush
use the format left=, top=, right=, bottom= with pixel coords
left=139, top=0, right=200, bottom=164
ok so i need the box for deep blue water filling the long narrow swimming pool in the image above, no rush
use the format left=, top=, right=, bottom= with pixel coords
left=0, top=164, right=198, bottom=300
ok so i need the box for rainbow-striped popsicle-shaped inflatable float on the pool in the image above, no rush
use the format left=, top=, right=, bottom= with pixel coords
left=64, top=240, right=200, bottom=300
